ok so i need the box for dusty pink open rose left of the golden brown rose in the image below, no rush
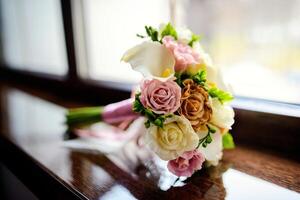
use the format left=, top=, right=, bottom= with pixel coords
left=141, top=79, right=181, bottom=114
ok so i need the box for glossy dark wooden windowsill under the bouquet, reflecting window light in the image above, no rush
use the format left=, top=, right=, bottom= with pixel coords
left=0, top=83, right=300, bottom=199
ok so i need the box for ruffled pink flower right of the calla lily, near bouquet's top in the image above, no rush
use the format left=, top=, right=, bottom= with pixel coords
left=162, top=36, right=200, bottom=72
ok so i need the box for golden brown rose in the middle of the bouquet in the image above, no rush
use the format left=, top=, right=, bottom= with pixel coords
left=179, top=79, right=212, bottom=131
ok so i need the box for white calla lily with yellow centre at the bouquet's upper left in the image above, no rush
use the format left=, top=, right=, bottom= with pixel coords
left=122, top=41, right=175, bottom=81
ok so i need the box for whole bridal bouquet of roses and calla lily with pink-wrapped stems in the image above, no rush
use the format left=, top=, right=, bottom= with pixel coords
left=67, top=23, right=234, bottom=177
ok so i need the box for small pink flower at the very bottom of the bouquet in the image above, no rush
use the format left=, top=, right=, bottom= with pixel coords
left=168, top=150, right=205, bottom=177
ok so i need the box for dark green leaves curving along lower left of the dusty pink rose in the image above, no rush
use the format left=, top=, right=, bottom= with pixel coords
left=132, top=93, right=172, bottom=128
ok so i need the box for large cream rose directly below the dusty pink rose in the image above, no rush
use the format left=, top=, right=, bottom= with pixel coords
left=145, top=115, right=199, bottom=160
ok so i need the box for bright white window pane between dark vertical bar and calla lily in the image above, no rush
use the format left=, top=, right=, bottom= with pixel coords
left=74, top=0, right=170, bottom=83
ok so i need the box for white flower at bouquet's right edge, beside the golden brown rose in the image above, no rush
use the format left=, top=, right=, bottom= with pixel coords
left=210, top=98, right=234, bottom=129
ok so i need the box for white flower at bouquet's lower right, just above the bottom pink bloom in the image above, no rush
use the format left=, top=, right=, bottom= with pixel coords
left=198, top=127, right=223, bottom=166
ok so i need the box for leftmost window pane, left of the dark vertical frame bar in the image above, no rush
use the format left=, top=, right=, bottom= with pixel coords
left=1, top=0, right=67, bottom=75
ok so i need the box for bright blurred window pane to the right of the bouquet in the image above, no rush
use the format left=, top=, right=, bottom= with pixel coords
left=178, top=0, right=300, bottom=104
